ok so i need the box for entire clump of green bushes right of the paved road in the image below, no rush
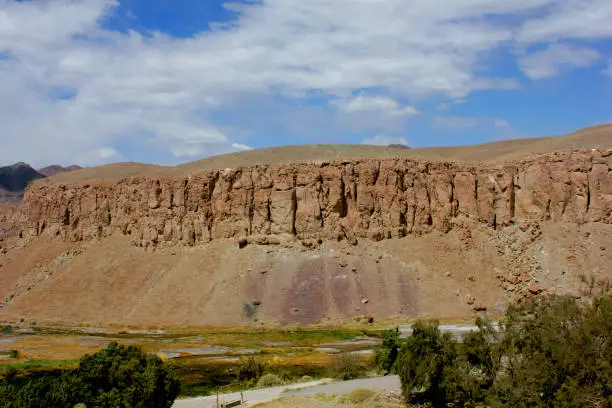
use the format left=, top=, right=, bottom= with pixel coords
left=395, top=296, right=612, bottom=408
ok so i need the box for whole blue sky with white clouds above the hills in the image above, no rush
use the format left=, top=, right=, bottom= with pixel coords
left=0, top=0, right=612, bottom=166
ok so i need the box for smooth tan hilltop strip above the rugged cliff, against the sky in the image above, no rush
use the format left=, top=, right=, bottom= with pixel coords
left=38, top=124, right=612, bottom=184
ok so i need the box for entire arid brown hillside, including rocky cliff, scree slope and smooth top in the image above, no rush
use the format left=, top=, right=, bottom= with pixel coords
left=0, top=126, right=612, bottom=326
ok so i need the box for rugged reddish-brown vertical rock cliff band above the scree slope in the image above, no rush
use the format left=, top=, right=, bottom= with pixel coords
left=20, top=148, right=612, bottom=247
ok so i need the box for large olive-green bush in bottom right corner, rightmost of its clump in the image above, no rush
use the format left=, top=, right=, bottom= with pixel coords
left=489, top=296, right=612, bottom=407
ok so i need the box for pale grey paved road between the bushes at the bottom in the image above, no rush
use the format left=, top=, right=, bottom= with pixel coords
left=172, top=375, right=400, bottom=408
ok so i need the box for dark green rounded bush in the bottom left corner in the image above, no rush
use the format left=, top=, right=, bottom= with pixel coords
left=0, top=342, right=180, bottom=408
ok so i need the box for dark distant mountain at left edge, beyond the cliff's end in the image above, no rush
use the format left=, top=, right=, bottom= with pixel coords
left=0, top=162, right=80, bottom=203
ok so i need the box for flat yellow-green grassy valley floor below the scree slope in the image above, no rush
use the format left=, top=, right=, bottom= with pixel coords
left=0, top=327, right=376, bottom=397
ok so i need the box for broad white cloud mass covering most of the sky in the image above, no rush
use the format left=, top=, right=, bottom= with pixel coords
left=0, top=0, right=612, bottom=164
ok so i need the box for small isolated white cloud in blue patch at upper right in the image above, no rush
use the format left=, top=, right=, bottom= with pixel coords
left=519, top=44, right=600, bottom=79
